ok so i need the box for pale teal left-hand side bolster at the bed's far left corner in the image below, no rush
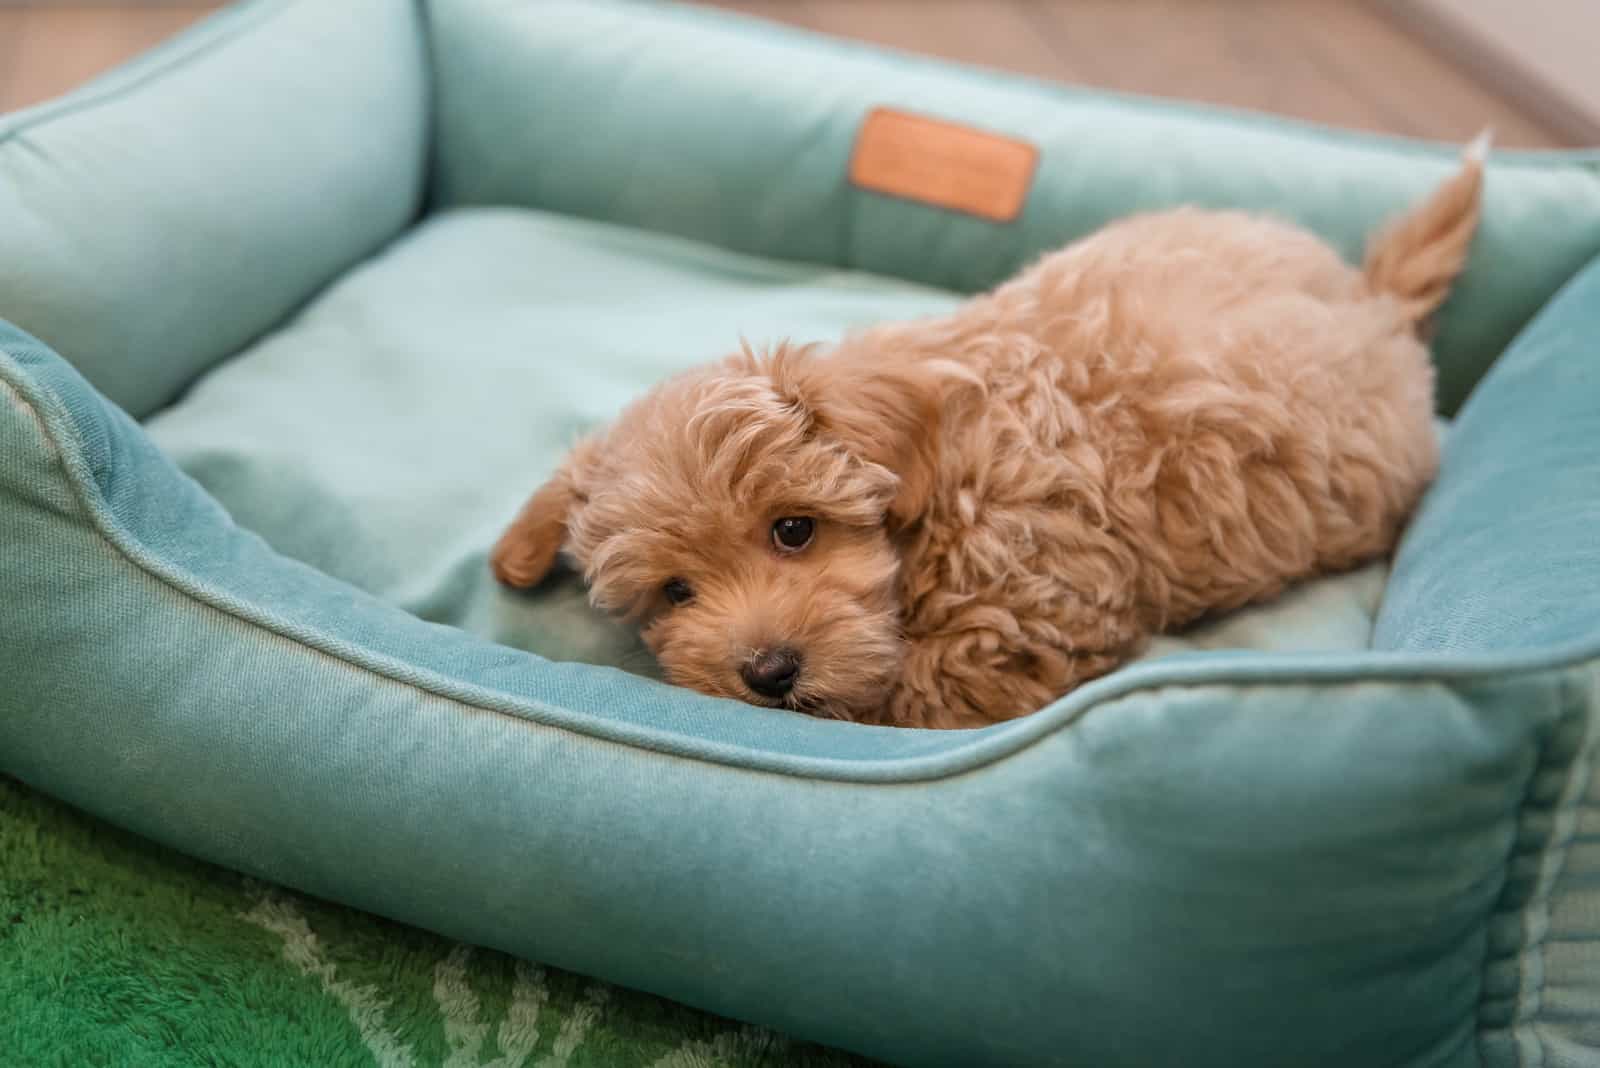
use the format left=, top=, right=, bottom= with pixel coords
left=0, top=0, right=427, bottom=416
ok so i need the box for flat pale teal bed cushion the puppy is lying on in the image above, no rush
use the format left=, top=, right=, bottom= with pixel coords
left=147, top=208, right=1387, bottom=675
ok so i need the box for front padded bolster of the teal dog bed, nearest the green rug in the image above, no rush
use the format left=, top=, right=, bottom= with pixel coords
left=0, top=333, right=1595, bottom=1065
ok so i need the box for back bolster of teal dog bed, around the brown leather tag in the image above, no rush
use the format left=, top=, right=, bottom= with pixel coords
left=429, top=0, right=1600, bottom=414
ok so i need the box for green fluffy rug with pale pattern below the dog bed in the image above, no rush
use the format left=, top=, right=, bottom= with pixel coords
left=0, top=777, right=866, bottom=1068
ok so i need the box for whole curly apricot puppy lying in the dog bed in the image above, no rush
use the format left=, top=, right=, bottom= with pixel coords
left=491, top=145, right=1485, bottom=727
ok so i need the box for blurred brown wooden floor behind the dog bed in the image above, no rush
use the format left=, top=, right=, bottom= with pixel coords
left=0, top=0, right=1568, bottom=147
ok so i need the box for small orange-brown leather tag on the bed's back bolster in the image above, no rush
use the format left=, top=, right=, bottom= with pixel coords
left=850, top=107, right=1038, bottom=222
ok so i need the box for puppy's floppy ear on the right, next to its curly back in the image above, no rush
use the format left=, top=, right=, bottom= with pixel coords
left=771, top=336, right=982, bottom=529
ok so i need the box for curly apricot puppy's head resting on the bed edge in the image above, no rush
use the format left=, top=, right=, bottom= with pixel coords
left=491, top=345, right=963, bottom=719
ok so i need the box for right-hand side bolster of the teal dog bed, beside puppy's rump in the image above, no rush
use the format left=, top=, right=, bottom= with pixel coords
left=1373, top=255, right=1600, bottom=1068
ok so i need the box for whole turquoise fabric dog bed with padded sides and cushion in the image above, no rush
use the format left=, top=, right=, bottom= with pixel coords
left=0, top=0, right=1600, bottom=1066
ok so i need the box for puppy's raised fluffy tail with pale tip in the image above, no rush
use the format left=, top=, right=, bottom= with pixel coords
left=1365, top=130, right=1490, bottom=325
